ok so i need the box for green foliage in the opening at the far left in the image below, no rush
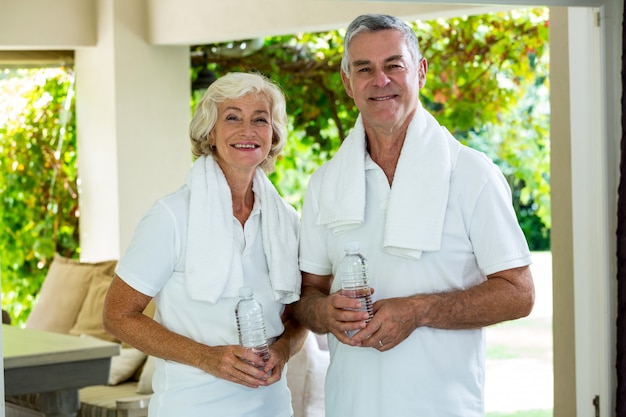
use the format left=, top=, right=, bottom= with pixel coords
left=0, top=69, right=78, bottom=323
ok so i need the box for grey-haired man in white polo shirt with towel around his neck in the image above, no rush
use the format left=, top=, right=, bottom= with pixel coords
left=296, top=15, right=534, bottom=417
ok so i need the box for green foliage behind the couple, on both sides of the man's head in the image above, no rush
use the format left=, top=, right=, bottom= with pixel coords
left=192, top=8, right=551, bottom=245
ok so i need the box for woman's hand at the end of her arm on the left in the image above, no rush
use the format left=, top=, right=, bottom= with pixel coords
left=200, top=345, right=270, bottom=388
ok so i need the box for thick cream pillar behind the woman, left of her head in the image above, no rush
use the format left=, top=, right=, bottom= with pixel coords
left=75, top=0, right=191, bottom=261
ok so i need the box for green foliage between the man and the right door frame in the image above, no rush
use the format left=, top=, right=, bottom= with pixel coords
left=416, top=8, right=552, bottom=250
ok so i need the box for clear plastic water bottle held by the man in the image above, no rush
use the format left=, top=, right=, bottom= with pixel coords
left=339, top=242, right=374, bottom=337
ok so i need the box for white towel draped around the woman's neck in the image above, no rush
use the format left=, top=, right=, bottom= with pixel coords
left=185, top=156, right=301, bottom=304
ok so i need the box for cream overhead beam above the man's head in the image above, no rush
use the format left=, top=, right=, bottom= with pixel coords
left=149, top=0, right=498, bottom=45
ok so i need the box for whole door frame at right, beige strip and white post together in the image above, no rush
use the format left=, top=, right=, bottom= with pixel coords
left=550, top=5, right=621, bottom=417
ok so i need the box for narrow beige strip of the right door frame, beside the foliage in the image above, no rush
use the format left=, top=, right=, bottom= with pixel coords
left=550, top=8, right=576, bottom=417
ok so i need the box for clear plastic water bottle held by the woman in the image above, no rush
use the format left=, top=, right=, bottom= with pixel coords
left=235, top=287, right=270, bottom=362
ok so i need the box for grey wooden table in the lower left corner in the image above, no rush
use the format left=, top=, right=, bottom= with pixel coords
left=2, top=325, right=120, bottom=416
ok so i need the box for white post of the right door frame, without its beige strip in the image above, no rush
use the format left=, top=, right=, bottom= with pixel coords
left=551, top=7, right=621, bottom=417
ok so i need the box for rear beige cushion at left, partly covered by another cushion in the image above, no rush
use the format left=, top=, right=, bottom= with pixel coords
left=26, top=255, right=117, bottom=333
